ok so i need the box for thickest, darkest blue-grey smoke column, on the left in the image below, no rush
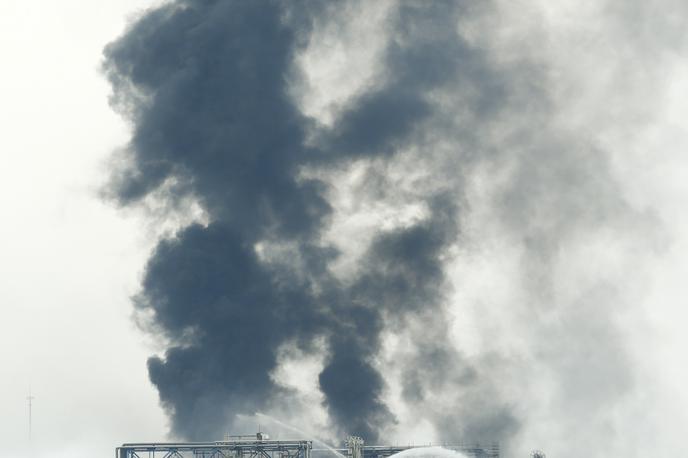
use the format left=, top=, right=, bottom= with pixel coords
left=106, top=1, right=329, bottom=439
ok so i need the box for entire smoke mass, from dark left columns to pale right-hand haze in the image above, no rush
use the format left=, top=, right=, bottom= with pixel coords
left=104, top=0, right=685, bottom=456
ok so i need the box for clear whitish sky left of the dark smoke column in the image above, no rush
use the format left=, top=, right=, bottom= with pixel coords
left=0, top=0, right=165, bottom=457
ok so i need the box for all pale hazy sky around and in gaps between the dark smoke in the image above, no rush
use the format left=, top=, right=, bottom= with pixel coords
left=0, top=0, right=688, bottom=457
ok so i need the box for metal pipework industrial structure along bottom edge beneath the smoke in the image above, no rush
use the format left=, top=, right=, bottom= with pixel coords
left=115, top=433, right=499, bottom=458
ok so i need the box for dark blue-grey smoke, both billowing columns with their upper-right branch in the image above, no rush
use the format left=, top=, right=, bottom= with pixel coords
left=106, top=2, right=478, bottom=441
